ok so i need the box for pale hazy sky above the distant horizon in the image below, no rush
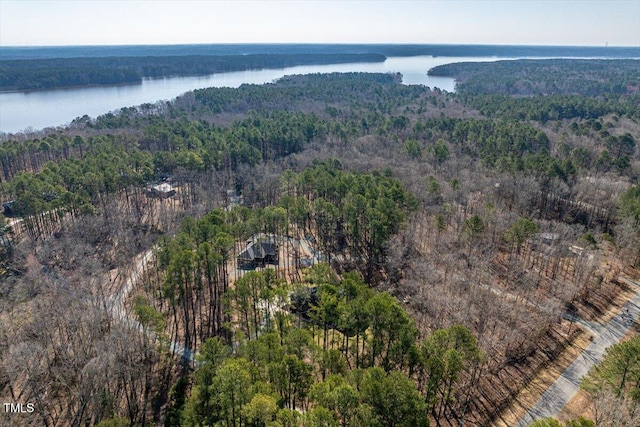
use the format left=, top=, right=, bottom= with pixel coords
left=0, top=0, right=640, bottom=47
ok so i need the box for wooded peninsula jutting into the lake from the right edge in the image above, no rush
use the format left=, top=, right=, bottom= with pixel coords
left=429, top=59, right=640, bottom=123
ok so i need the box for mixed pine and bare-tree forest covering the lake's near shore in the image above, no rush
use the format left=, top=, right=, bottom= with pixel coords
left=0, top=60, right=640, bottom=427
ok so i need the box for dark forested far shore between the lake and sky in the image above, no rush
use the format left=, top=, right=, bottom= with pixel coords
left=0, top=44, right=638, bottom=91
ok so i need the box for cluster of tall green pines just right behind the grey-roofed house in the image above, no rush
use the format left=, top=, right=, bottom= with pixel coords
left=294, top=160, right=417, bottom=278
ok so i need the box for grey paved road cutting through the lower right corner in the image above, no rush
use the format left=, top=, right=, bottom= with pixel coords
left=517, top=279, right=640, bottom=427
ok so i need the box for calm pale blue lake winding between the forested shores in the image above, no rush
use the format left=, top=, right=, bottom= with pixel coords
left=0, top=56, right=516, bottom=133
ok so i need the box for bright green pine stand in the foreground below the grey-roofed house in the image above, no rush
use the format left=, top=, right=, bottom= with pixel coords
left=183, top=262, right=483, bottom=427
